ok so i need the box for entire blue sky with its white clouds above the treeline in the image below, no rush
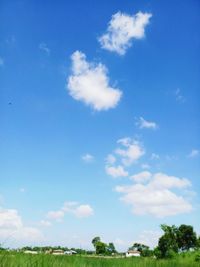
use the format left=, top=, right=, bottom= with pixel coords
left=0, top=0, right=200, bottom=250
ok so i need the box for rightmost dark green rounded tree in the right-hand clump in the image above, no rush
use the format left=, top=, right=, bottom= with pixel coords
left=177, top=224, right=198, bottom=251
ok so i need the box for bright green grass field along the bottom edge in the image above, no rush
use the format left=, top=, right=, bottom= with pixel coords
left=0, top=252, right=200, bottom=267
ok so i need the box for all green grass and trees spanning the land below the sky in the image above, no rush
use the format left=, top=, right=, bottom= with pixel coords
left=0, top=224, right=200, bottom=267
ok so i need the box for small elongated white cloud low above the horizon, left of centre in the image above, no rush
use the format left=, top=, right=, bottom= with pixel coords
left=46, top=201, right=94, bottom=222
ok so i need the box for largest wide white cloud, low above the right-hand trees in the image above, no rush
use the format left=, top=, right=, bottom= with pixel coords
left=116, top=173, right=192, bottom=217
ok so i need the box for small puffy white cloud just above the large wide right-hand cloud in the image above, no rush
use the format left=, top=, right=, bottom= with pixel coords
left=115, top=138, right=145, bottom=166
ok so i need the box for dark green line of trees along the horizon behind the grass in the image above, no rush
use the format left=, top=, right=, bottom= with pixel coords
left=0, top=224, right=200, bottom=261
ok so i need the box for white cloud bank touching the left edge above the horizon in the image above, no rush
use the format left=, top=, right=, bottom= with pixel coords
left=0, top=208, right=44, bottom=246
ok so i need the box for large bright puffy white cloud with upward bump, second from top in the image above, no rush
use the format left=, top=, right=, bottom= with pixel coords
left=67, top=51, right=122, bottom=111
